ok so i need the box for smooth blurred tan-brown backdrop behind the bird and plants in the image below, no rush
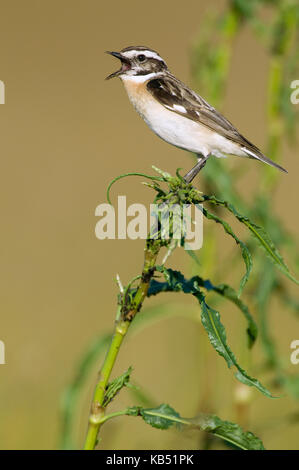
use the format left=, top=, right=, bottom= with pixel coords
left=0, top=0, right=299, bottom=449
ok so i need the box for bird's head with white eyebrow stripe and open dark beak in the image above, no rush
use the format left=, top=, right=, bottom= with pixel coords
left=106, top=46, right=167, bottom=80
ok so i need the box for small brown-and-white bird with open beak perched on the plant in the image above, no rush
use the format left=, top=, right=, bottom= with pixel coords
left=107, top=46, right=287, bottom=183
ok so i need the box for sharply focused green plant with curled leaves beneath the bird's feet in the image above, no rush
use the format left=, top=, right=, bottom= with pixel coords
left=75, top=168, right=298, bottom=449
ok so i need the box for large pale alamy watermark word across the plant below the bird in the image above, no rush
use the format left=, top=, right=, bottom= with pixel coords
left=95, top=196, right=203, bottom=250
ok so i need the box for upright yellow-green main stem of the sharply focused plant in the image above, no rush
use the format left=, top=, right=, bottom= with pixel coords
left=84, top=240, right=161, bottom=450
